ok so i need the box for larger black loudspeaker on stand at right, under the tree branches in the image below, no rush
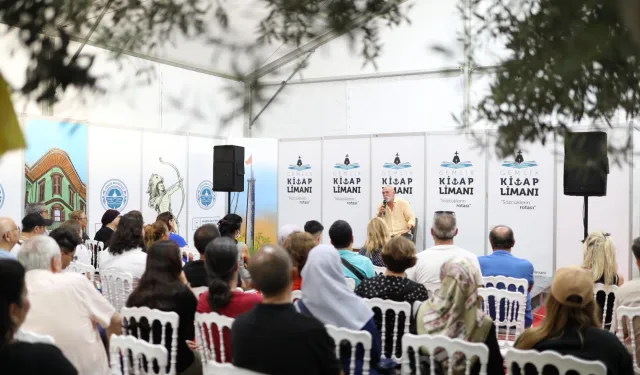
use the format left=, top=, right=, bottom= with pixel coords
left=564, top=132, right=609, bottom=197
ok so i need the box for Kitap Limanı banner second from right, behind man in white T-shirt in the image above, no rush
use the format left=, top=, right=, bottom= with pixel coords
left=425, top=134, right=487, bottom=255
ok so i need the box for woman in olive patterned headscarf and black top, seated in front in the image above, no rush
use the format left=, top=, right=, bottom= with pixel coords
left=417, top=257, right=504, bottom=374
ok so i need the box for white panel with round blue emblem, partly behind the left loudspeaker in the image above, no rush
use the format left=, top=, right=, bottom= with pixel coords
left=185, top=137, right=227, bottom=246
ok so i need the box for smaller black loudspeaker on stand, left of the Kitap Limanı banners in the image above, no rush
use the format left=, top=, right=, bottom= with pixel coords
left=213, top=146, right=244, bottom=192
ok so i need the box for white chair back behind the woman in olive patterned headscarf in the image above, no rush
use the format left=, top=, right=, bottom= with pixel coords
left=402, top=334, right=489, bottom=375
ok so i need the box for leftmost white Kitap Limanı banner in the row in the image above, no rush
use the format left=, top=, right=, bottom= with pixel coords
left=278, top=139, right=327, bottom=232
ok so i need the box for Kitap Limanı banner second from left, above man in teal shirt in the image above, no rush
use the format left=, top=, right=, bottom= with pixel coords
left=322, top=137, right=372, bottom=248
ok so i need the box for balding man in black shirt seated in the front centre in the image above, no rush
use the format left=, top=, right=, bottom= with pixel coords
left=230, top=245, right=340, bottom=375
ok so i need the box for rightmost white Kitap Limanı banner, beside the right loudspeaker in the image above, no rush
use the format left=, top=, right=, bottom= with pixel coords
left=488, top=137, right=555, bottom=276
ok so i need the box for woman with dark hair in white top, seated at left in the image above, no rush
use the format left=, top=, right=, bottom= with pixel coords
left=98, top=214, right=147, bottom=286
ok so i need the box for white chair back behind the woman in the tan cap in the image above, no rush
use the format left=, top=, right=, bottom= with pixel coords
left=504, top=349, right=607, bottom=375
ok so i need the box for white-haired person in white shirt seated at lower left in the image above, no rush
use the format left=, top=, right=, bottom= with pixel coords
left=18, top=236, right=120, bottom=375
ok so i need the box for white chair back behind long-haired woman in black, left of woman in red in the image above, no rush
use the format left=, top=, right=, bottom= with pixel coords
left=120, top=307, right=180, bottom=374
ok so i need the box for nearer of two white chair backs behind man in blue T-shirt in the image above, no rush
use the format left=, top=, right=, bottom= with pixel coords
left=478, top=288, right=527, bottom=347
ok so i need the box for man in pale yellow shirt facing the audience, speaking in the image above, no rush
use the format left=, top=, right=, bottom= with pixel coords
left=377, top=186, right=416, bottom=240
